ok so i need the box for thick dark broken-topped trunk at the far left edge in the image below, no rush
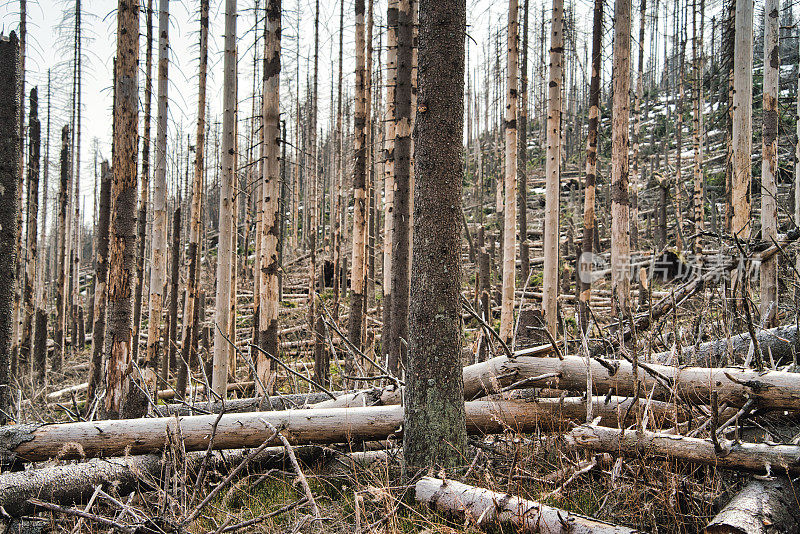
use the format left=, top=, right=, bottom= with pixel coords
left=0, top=32, right=22, bottom=424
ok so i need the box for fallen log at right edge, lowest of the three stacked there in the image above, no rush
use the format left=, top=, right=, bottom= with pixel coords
left=567, top=425, right=800, bottom=474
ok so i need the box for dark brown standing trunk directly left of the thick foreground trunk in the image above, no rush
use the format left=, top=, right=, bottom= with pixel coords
left=382, top=0, right=414, bottom=376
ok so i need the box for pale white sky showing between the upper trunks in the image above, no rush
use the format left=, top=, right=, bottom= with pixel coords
left=0, top=0, right=732, bottom=224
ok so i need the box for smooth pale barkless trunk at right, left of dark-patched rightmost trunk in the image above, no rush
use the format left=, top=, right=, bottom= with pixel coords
left=731, top=0, right=753, bottom=241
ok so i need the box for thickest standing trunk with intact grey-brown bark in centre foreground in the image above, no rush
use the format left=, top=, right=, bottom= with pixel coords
left=403, top=0, right=468, bottom=469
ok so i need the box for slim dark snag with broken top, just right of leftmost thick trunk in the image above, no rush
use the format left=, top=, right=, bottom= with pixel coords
left=18, top=87, right=41, bottom=377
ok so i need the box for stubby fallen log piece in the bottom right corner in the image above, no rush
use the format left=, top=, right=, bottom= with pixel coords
left=705, top=477, right=800, bottom=534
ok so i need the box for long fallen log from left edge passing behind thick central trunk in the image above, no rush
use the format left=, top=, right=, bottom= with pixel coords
left=0, top=397, right=671, bottom=462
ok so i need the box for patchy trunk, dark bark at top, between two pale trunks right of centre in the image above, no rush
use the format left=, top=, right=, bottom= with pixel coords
left=578, top=0, right=603, bottom=332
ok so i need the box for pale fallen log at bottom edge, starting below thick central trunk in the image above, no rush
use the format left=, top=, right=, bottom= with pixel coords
left=414, top=477, right=636, bottom=534
